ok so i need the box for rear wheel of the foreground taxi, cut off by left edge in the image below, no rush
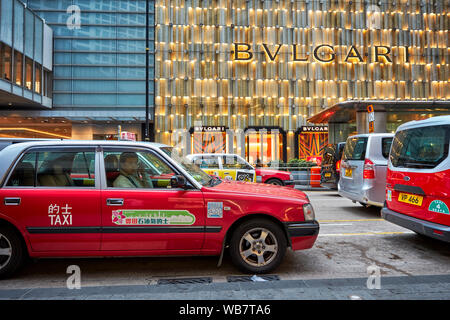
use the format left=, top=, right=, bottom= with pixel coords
left=0, top=227, right=25, bottom=278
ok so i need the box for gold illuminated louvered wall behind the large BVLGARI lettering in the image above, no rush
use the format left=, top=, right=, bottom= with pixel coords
left=155, top=0, right=450, bottom=159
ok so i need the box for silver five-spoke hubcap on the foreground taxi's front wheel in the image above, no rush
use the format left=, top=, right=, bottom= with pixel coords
left=239, top=228, right=278, bottom=267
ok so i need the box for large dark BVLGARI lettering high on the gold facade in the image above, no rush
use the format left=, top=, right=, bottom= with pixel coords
left=232, top=43, right=409, bottom=63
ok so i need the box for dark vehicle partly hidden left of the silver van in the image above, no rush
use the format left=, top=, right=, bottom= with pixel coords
left=320, top=142, right=345, bottom=189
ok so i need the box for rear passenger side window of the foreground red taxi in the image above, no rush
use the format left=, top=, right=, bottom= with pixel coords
left=37, top=151, right=95, bottom=187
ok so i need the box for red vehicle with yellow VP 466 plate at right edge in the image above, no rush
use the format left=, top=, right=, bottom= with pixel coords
left=381, top=116, right=450, bottom=242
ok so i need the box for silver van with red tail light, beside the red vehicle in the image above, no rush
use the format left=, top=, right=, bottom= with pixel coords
left=338, top=133, right=394, bottom=207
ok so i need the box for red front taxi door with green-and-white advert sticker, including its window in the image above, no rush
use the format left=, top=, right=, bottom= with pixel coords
left=101, top=147, right=206, bottom=253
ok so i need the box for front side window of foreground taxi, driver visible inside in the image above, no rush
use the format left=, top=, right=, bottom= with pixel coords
left=104, top=151, right=175, bottom=189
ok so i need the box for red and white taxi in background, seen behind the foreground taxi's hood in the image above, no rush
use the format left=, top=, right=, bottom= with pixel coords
left=187, top=153, right=295, bottom=187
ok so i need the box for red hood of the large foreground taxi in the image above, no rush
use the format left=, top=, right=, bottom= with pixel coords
left=205, top=180, right=309, bottom=202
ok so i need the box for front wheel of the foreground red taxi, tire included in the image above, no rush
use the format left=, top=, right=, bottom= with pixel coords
left=230, top=218, right=287, bottom=274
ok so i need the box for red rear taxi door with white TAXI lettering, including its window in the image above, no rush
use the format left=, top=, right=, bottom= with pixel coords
left=0, top=146, right=101, bottom=252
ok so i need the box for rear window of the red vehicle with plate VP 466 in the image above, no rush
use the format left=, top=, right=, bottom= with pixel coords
left=390, top=125, right=450, bottom=169
